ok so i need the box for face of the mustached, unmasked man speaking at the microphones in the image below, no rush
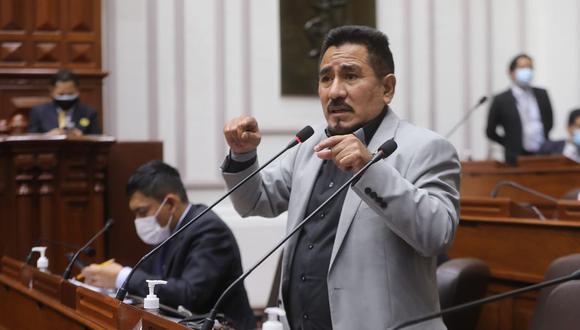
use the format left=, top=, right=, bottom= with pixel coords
left=318, top=43, right=395, bottom=134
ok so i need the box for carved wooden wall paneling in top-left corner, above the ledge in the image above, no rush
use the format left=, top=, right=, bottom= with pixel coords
left=0, top=0, right=101, bottom=70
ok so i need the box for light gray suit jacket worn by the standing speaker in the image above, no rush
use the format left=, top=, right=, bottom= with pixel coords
left=223, top=110, right=460, bottom=330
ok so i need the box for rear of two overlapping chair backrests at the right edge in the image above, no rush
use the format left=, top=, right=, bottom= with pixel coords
left=531, top=253, right=580, bottom=329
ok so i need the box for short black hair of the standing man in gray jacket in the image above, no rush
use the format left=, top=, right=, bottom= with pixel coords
left=320, top=25, right=395, bottom=79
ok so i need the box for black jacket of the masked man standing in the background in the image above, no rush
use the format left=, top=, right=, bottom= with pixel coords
left=486, top=87, right=553, bottom=164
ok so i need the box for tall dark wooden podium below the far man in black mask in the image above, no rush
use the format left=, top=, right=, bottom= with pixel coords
left=0, top=134, right=115, bottom=273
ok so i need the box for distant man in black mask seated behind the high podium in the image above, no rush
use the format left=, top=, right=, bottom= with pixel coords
left=28, top=70, right=101, bottom=136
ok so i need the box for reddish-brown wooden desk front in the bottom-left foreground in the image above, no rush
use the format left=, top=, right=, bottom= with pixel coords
left=0, top=257, right=187, bottom=330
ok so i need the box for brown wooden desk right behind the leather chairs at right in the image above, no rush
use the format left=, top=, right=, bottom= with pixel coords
left=449, top=197, right=580, bottom=330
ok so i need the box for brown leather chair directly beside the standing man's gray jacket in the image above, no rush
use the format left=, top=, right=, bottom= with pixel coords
left=437, top=258, right=490, bottom=330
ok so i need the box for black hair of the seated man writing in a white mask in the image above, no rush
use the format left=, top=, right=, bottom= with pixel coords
left=126, top=160, right=188, bottom=202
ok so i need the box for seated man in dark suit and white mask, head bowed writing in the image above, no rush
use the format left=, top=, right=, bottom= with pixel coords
left=82, top=161, right=256, bottom=329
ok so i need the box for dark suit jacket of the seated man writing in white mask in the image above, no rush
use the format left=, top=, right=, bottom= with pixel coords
left=128, top=204, right=256, bottom=329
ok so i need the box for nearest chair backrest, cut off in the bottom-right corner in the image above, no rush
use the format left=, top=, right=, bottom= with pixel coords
left=530, top=281, right=580, bottom=330
